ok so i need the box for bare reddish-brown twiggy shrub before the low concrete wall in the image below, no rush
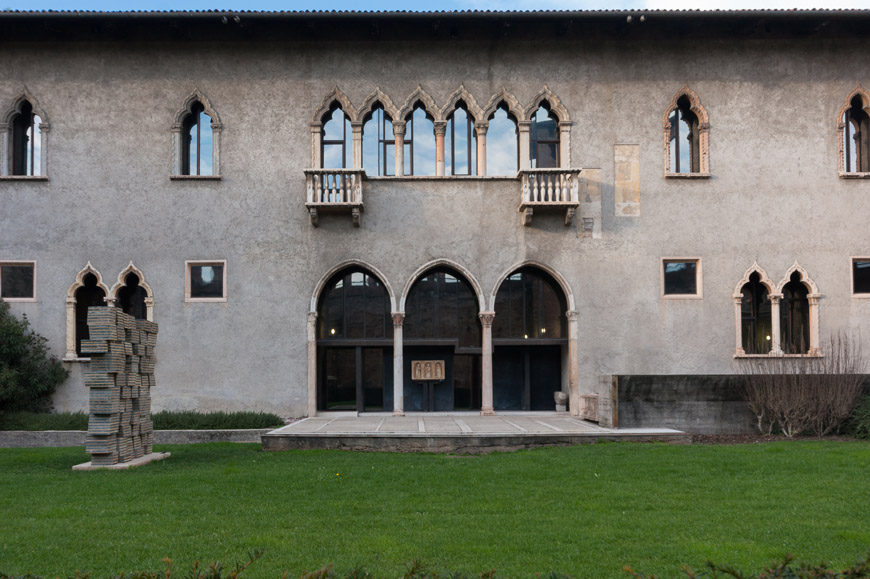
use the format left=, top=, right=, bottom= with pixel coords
left=741, top=333, right=867, bottom=437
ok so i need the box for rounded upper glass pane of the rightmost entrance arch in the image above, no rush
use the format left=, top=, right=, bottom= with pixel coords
left=492, top=268, right=566, bottom=339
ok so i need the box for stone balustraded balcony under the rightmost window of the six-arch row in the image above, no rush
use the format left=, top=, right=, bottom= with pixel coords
left=519, top=169, right=580, bottom=225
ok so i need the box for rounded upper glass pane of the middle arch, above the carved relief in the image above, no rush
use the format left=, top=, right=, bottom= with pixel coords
left=404, top=269, right=480, bottom=347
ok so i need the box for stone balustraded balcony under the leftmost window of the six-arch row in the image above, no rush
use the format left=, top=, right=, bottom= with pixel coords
left=305, top=169, right=365, bottom=227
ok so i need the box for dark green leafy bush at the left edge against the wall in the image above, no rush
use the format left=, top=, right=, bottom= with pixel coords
left=0, top=299, right=68, bottom=414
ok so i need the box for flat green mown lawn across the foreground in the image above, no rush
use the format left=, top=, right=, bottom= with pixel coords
left=0, top=441, right=870, bottom=578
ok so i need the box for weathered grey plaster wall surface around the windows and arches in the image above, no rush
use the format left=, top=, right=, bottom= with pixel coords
left=0, top=27, right=870, bottom=416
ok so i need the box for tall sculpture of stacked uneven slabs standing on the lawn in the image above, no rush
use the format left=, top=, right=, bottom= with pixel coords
left=81, top=306, right=157, bottom=466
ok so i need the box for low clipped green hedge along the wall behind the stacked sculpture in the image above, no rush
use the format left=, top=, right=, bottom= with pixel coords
left=0, top=412, right=284, bottom=430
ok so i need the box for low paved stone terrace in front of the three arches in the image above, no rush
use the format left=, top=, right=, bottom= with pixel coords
left=263, top=412, right=691, bottom=453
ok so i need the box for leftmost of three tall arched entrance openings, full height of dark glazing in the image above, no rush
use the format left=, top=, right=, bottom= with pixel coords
left=317, top=266, right=393, bottom=412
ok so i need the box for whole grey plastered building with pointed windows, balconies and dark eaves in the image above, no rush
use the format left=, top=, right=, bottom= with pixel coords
left=0, top=11, right=870, bottom=431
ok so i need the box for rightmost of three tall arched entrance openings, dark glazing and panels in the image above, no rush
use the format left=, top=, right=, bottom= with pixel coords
left=492, top=266, right=568, bottom=411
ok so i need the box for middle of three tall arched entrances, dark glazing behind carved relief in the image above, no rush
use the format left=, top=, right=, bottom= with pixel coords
left=403, top=266, right=481, bottom=412
